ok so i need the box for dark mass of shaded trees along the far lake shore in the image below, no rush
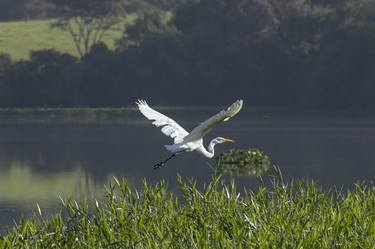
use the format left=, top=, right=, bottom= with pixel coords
left=0, top=0, right=375, bottom=108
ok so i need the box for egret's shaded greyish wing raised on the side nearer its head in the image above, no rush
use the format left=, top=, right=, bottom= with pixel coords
left=184, top=99, right=243, bottom=141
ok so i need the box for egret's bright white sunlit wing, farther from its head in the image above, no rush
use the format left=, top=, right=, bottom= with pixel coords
left=135, top=100, right=189, bottom=144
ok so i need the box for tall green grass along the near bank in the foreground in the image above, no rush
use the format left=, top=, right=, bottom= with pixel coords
left=0, top=174, right=375, bottom=248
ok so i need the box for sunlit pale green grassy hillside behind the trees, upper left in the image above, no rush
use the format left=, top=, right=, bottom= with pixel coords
left=0, top=20, right=125, bottom=60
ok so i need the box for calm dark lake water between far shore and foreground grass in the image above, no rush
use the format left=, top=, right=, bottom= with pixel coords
left=0, top=108, right=375, bottom=232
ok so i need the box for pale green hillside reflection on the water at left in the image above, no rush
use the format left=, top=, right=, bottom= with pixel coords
left=0, top=161, right=102, bottom=205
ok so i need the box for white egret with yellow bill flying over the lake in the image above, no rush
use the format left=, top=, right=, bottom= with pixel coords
left=136, top=100, right=242, bottom=169
